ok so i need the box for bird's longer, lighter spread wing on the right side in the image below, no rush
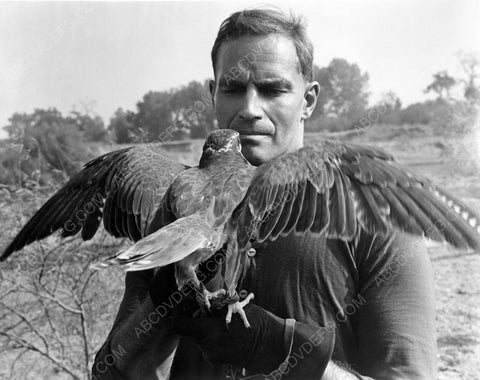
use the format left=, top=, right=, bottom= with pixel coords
left=233, top=141, right=480, bottom=248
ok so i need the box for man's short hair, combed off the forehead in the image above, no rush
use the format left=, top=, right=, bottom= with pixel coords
left=211, top=8, right=313, bottom=81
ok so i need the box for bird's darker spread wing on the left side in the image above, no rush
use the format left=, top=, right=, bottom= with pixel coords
left=0, top=144, right=188, bottom=260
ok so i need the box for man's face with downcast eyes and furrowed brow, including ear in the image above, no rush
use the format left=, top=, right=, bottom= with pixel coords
left=210, top=35, right=319, bottom=165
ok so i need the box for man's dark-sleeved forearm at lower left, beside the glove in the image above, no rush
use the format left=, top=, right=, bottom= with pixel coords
left=93, top=297, right=178, bottom=380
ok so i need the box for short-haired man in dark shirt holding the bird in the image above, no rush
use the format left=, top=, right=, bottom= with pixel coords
left=93, top=9, right=436, bottom=379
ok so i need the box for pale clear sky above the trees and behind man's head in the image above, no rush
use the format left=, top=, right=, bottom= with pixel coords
left=0, top=0, right=480, bottom=138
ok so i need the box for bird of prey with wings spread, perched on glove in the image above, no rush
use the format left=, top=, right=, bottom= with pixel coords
left=0, top=129, right=480, bottom=326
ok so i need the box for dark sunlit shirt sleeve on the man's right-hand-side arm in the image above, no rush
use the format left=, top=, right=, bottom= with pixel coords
left=356, top=233, right=437, bottom=379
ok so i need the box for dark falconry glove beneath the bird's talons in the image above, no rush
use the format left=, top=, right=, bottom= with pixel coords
left=173, top=300, right=335, bottom=379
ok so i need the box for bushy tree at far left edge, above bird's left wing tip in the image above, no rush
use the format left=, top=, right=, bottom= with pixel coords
left=0, top=108, right=107, bottom=186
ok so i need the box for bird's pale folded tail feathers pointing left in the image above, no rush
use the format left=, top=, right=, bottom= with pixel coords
left=92, top=214, right=221, bottom=271
